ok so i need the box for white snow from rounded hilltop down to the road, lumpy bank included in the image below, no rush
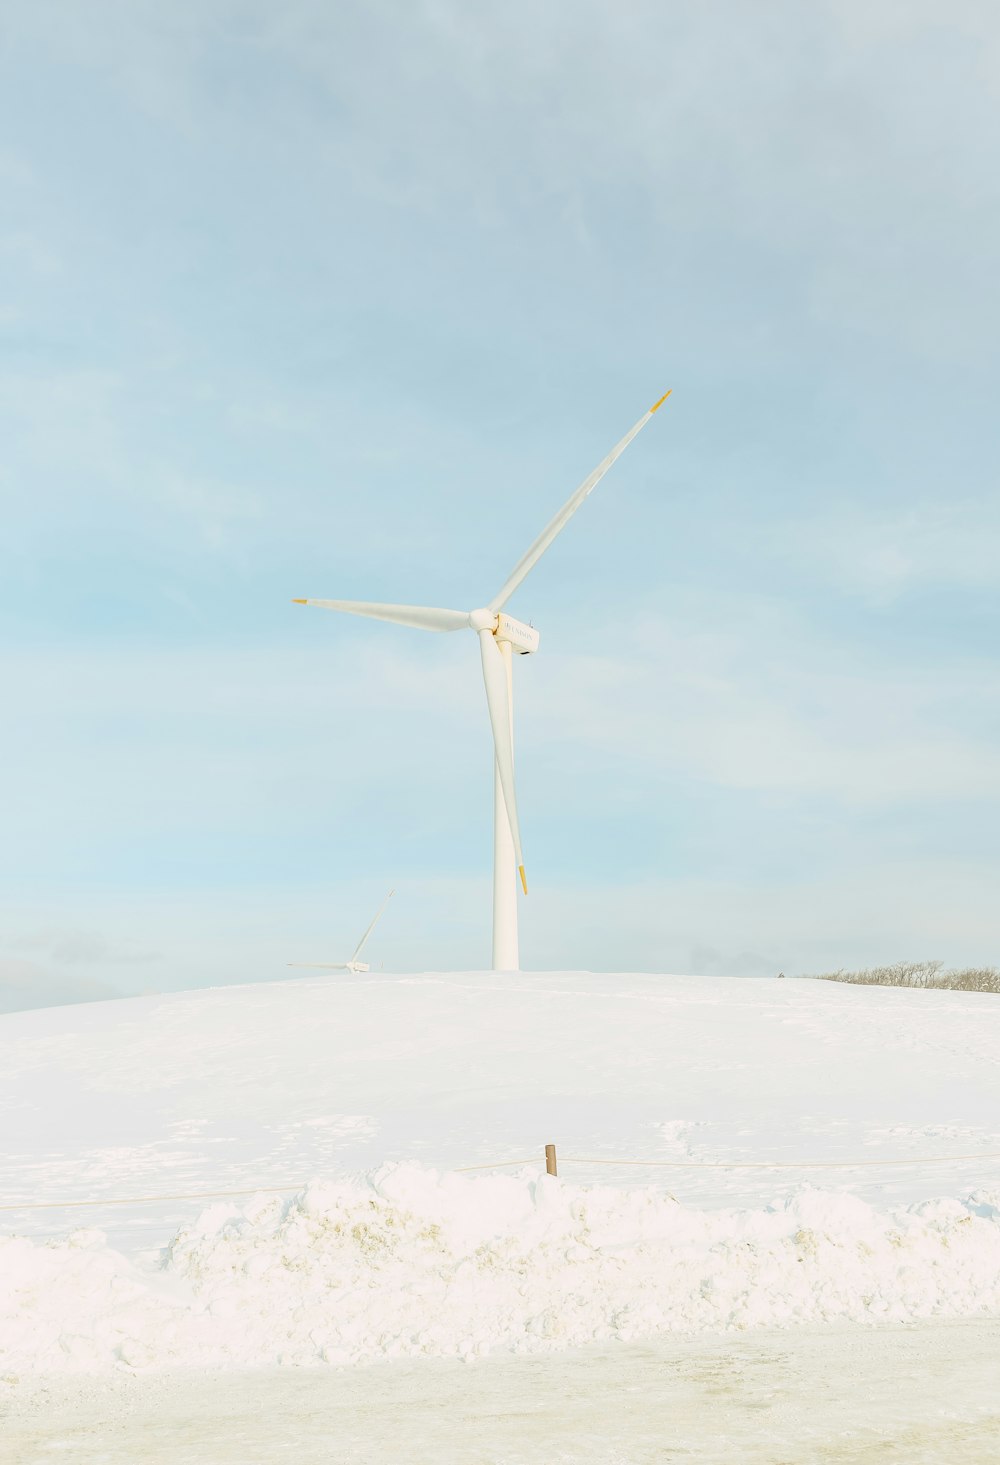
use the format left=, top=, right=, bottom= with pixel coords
left=0, top=974, right=1000, bottom=1380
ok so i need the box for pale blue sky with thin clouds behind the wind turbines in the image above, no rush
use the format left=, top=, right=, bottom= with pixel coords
left=0, top=0, right=1000, bottom=1001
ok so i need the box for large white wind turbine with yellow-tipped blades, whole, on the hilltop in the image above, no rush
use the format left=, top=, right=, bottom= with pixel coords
left=294, top=391, right=671, bottom=971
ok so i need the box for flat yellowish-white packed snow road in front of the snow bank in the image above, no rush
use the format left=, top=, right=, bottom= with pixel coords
left=7, top=1320, right=1000, bottom=1465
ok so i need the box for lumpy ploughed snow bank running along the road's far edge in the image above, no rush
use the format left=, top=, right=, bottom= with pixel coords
left=0, top=1163, right=1000, bottom=1379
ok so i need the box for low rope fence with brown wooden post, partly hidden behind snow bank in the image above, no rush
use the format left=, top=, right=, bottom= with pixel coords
left=0, top=1144, right=1000, bottom=1212
